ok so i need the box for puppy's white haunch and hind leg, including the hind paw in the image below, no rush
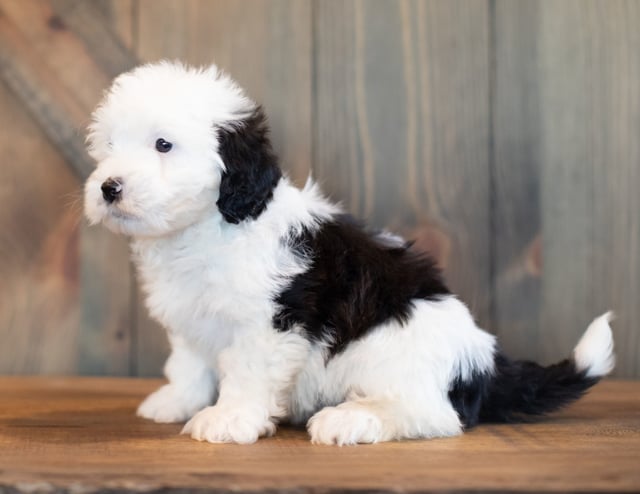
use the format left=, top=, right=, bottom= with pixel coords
left=302, top=297, right=495, bottom=445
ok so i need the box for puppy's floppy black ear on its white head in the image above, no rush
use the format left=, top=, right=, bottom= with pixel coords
left=217, top=107, right=282, bottom=223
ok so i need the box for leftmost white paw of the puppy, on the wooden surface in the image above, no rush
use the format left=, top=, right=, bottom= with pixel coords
left=137, top=384, right=209, bottom=423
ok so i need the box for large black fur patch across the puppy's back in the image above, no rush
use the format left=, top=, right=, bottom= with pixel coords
left=274, top=215, right=450, bottom=355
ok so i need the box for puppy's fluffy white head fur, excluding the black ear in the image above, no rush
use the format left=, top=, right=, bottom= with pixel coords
left=85, top=62, right=256, bottom=236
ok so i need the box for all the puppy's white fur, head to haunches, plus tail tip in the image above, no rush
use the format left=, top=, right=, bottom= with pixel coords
left=85, top=62, right=612, bottom=445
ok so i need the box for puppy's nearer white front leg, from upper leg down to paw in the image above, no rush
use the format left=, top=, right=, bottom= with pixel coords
left=182, top=328, right=310, bottom=444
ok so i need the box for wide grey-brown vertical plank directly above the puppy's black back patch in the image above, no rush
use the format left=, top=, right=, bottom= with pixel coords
left=314, top=0, right=491, bottom=324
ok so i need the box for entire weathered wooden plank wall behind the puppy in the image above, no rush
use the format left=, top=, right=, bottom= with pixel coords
left=0, top=0, right=640, bottom=377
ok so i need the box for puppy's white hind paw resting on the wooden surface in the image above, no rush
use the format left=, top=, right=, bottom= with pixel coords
left=307, top=406, right=383, bottom=446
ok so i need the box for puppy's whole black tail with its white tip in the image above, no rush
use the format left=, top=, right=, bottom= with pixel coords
left=450, top=312, right=615, bottom=427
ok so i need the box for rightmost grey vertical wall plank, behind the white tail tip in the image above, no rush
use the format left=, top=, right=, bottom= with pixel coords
left=540, top=0, right=640, bottom=376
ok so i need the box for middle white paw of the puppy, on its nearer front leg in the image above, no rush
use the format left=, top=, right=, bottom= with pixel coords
left=182, top=405, right=276, bottom=444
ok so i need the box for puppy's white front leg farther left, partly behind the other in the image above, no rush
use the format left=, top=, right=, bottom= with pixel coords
left=137, top=336, right=216, bottom=423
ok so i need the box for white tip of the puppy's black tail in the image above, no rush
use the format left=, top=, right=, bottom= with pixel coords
left=573, top=312, right=616, bottom=377
